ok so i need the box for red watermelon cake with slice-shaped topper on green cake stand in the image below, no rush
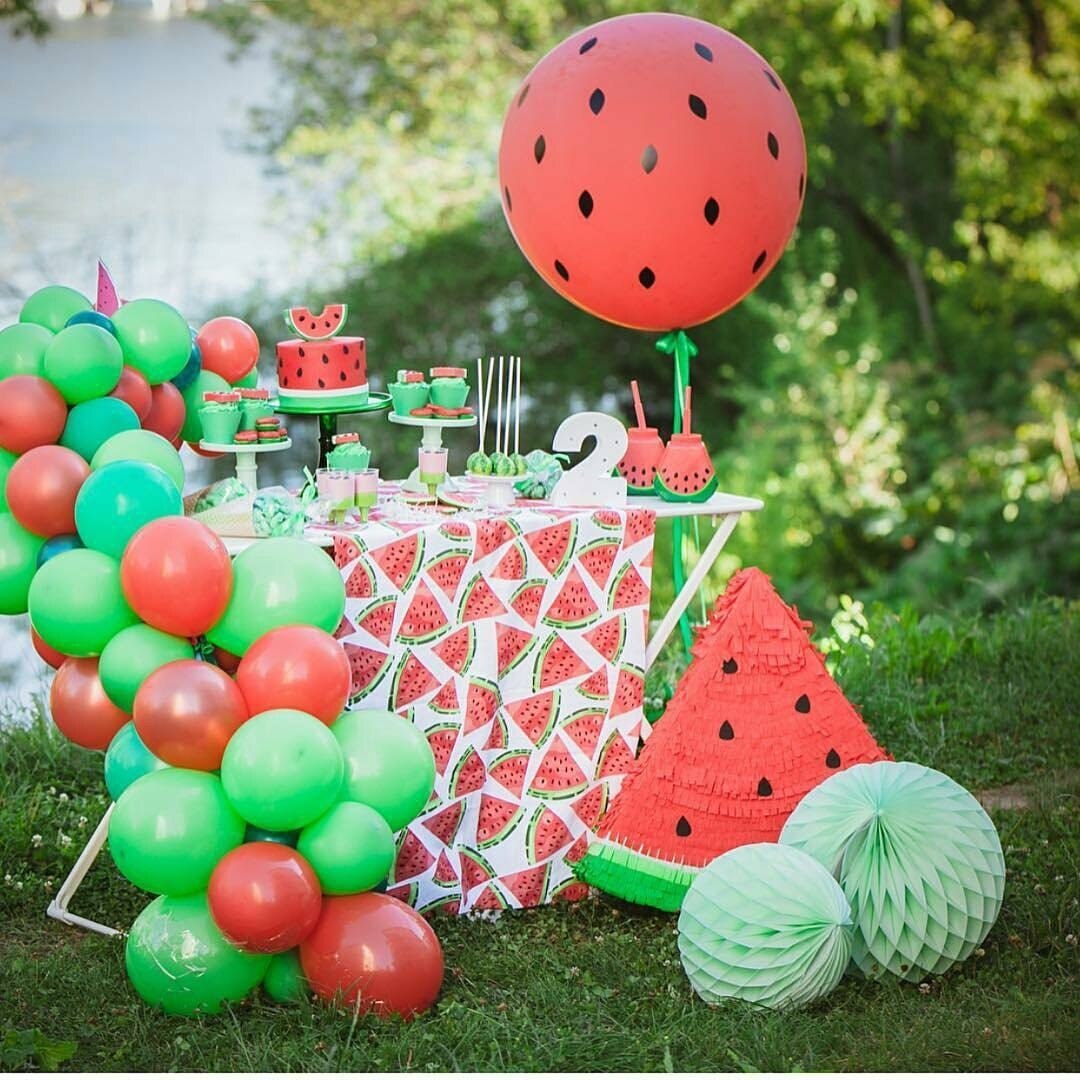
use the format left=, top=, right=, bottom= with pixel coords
left=278, top=303, right=367, bottom=409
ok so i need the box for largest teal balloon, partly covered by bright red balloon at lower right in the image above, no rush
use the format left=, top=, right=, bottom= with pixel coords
left=75, top=461, right=184, bottom=558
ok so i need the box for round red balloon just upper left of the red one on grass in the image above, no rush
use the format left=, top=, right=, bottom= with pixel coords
left=206, top=840, right=323, bottom=953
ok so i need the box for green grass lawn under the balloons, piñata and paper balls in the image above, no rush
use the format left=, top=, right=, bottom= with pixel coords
left=0, top=600, right=1080, bottom=1071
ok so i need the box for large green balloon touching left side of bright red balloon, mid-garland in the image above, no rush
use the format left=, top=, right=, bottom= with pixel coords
left=29, top=548, right=138, bottom=657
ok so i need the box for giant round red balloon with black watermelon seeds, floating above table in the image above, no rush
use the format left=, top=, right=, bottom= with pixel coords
left=499, top=13, right=806, bottom=330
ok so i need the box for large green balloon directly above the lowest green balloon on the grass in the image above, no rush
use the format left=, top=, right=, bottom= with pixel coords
left=109, top=768, right=245, bottom=896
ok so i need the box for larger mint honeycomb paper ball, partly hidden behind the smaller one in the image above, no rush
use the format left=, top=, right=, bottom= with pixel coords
left=780, top=761, right=1005, bottom=981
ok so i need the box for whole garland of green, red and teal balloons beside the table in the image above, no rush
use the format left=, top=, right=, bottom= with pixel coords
left=0, top=280, right=443, bottom=1016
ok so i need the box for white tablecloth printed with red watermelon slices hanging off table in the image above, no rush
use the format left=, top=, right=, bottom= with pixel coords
left=335, top=508, right=654, bottom=913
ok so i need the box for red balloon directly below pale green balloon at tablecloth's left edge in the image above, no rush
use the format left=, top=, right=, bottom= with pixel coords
left=237, top=626, right=351, bottom=725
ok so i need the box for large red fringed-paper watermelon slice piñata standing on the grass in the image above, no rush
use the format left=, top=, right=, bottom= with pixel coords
left=577, top=568, right=888, bottom=910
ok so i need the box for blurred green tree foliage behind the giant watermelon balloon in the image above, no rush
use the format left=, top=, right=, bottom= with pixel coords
left=212, top=0, right=1080, bottom=612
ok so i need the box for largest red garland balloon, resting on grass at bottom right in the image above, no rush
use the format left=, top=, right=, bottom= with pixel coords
left=300, top=892, right=443, bottom=1020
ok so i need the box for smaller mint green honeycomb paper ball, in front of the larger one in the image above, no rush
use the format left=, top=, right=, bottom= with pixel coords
left=678, top=843, right=851, bottom=1009
